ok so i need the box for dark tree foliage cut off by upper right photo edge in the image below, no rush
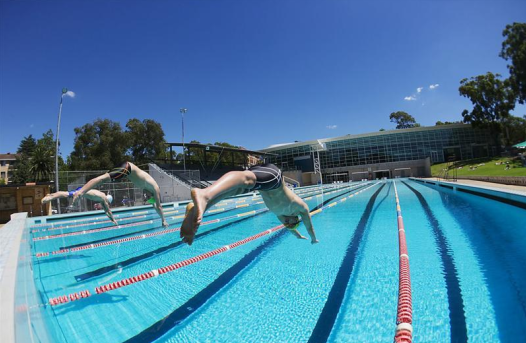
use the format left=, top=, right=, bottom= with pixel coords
left=499, top=23, right=526, bottom=104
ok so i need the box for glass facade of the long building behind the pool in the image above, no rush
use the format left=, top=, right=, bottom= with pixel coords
left=261, top=124, right=495, bottom=172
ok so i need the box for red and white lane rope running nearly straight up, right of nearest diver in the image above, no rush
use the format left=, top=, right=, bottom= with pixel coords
left=393, top=181, right=413, bottom=343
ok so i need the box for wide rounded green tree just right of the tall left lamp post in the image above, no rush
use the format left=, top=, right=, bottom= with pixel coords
left=70, top=119, right=129, bottom=170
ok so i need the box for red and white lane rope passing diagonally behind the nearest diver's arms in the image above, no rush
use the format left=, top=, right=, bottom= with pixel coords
left=49, top=183, right=378, bottom=306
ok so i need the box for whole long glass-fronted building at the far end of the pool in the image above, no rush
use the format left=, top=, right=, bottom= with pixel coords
left=261, top=124, right=496, bottom=185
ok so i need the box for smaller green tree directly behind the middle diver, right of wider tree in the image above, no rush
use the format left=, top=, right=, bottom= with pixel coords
left=126, top=118, right=166, bottom=164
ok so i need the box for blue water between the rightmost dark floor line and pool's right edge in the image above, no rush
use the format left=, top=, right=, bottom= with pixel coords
left=411, top=182, right=526, bottom=342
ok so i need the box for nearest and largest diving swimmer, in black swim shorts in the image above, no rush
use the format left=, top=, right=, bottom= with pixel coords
left=181, top=164, right=318, bottom=245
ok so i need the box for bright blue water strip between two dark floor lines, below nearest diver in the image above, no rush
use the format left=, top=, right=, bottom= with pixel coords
left=145, top=186, right=388, bottom=342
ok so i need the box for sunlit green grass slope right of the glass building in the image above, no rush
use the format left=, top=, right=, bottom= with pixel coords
left=431, top=157, right=526, bottom=177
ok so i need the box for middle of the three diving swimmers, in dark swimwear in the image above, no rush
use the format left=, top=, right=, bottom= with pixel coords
left=73, top=162, right=168, bottom=228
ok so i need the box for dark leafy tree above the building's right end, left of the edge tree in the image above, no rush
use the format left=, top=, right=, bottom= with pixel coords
left=459, top=72, right=515, bottom=153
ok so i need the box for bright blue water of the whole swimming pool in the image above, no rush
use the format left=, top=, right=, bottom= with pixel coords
left=23, top=179, right=526, bottom=342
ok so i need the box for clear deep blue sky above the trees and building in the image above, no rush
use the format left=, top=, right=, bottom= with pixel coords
left=0, top=0, right=526, bottom=156
